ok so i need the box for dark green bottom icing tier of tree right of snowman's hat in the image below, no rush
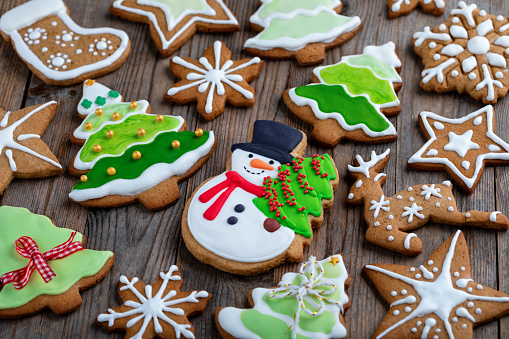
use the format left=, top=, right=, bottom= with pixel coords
left=295, top=84, right=391, bottom=132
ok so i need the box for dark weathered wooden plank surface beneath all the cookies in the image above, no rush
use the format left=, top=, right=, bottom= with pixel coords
left=0, top=0, right=509, bottom=338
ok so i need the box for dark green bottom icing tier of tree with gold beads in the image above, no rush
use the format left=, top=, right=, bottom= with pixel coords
left=73, top=131, right=209, bottom=190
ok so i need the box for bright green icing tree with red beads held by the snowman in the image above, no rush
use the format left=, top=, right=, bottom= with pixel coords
left=253, top=154, right=336, bottom=238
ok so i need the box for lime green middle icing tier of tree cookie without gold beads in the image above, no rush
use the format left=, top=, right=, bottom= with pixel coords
left=320, top=63, right=398, bottom=105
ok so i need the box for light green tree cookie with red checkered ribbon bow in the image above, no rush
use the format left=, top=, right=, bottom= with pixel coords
left=0, top=206, right=115, bottom=319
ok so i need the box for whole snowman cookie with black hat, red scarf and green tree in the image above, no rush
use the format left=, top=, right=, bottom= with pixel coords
left=182, top=120, right=338, bottom=275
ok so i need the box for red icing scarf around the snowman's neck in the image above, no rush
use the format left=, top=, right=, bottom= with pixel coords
left=198, top=171, right=265, bottom=221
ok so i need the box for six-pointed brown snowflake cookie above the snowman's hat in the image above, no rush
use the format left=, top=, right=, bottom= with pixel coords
left=164, top=41, right=263, bottom=121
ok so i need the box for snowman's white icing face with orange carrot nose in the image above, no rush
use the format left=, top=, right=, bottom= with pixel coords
left=232, top=149, right=281, bottom=186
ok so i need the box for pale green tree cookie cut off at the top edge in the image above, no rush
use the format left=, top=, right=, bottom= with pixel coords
left=244, top=0, right=362, bottom=66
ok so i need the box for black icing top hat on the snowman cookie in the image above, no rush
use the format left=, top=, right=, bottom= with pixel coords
left=232, top=120, right=302, bottom=164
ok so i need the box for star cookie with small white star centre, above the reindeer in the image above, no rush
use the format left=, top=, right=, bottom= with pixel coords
left=408, top=106, right=509, bottom=193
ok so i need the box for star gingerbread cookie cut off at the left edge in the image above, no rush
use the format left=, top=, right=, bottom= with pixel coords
left=0, top=101, right=62, bottom=194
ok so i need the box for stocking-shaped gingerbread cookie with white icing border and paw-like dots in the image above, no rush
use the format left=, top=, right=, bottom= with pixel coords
left=0, top=0, right=131, bottom=86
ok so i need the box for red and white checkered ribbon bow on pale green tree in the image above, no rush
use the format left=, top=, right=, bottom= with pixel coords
left=0, top=231, right=85, bottom=291
